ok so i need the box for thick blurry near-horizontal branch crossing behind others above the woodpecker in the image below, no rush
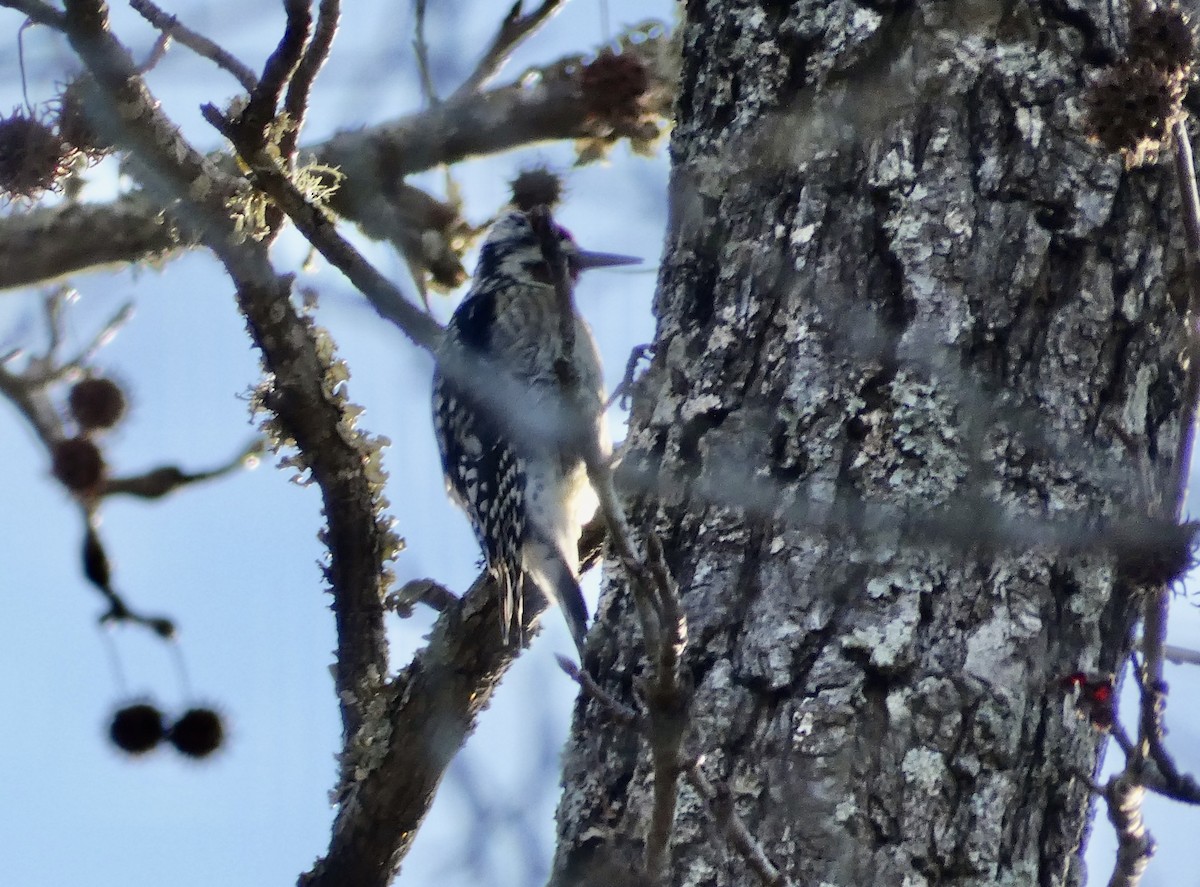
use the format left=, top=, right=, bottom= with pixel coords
left=0, top=31, right=670, bottom=289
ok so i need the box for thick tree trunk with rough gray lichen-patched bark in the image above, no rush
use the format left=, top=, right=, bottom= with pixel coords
left=552, top=0, right=1186, bottom=887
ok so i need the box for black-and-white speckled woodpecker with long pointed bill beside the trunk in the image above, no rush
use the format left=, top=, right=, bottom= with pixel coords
left=433, top=206, right=640, bottom=661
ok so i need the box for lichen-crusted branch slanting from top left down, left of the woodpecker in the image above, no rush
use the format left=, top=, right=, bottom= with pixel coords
left=60, top=0, right=401, bottom=748
